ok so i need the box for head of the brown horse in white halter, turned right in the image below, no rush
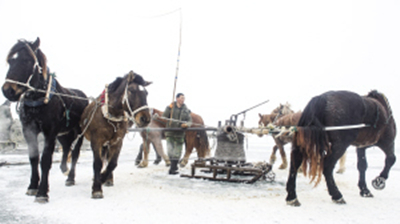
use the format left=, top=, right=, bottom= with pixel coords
left=108, top=71, right=152, bottom=127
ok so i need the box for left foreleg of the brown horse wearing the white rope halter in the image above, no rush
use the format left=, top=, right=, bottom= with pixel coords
left=90, top=142, right=103, bottom=199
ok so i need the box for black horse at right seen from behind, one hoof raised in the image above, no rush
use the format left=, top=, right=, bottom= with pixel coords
left=286, top=90, right=396, bottom=206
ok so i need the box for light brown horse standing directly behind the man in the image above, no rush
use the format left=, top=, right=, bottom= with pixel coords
left=136, top=109, right=210, bottom=168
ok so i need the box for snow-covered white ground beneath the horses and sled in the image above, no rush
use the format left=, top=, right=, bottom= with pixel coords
left=0, top=133, right=400, bottom=224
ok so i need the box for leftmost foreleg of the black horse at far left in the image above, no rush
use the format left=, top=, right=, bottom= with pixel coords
left=23, top=125, right=40, bottom=196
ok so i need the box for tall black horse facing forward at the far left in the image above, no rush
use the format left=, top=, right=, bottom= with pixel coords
left=2, top=38, right=88, bottom=203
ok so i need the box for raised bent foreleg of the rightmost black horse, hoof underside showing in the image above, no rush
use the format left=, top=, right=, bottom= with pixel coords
left=372, top=140, right=396, bottom=190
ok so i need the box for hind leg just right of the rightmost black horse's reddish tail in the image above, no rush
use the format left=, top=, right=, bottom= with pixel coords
left=323, top=143, right=347, bottom=204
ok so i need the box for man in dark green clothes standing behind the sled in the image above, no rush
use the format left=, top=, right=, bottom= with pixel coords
left=163, top=93, right=192, bottom=175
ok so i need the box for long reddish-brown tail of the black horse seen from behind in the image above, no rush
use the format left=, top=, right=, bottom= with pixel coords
left=292, top=95, right=330, bottom=186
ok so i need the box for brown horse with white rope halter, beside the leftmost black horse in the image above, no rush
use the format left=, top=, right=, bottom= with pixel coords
left=80, top=71, right=151, bottom=198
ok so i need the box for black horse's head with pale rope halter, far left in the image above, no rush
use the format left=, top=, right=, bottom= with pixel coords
left=2, top=38, right=47, bottom=101
